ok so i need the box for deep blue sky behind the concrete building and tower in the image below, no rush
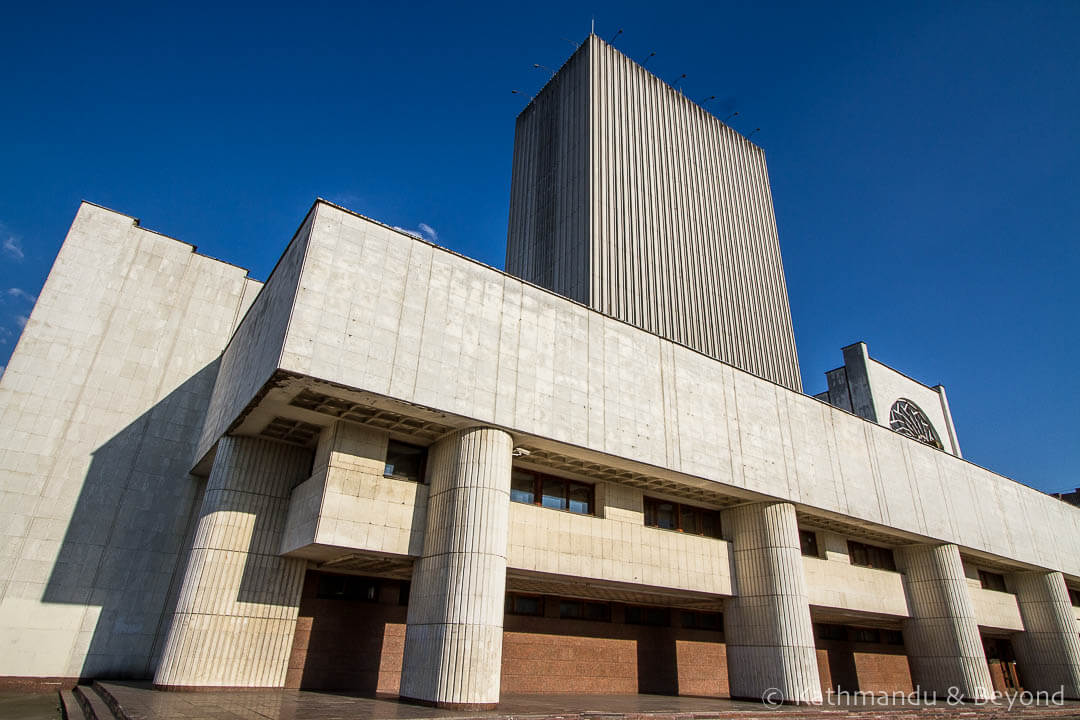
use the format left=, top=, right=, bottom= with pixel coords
left=0, top=0, right=1080, bottom=491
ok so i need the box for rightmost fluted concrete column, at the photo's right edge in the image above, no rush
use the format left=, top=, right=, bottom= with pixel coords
left=1009, top=572, right=1080, bottom=699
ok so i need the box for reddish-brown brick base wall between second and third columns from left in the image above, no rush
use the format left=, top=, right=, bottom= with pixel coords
left=502, top=615, right=728, bottom=697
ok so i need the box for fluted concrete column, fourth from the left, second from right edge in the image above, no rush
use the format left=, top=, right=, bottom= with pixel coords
left=899, top=545, right=993, bottom=699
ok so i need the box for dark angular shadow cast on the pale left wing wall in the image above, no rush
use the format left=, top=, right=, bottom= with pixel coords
left=41, top=361, right=225, bottom=679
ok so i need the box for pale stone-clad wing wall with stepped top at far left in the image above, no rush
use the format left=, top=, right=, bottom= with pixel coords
left=0, top=203, right=260, bottom=678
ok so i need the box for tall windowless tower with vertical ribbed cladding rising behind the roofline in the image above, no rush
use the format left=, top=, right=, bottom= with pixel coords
left=507, top=35, right=802, bottom=392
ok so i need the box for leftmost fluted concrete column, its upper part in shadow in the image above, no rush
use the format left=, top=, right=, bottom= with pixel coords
left=153, top=437, right=311, bottom=688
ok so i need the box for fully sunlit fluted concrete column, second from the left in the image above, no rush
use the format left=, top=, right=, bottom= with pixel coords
left=401, top=427, right=513, bottom=709
